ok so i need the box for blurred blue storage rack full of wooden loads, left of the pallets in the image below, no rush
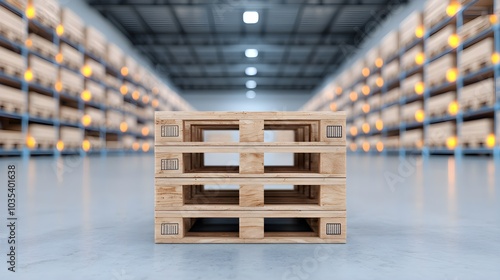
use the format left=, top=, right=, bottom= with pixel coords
left=0, top=0, right=191, bottom=157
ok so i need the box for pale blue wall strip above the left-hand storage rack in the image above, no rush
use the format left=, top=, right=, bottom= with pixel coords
left=58, top=0, right=180, bottom=97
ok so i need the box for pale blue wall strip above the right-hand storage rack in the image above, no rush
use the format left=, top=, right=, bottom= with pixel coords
left=313, top=0, right=426, bottom=96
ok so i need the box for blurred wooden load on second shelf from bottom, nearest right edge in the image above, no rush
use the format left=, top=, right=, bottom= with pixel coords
left=458, top=78, right=495, bottom=111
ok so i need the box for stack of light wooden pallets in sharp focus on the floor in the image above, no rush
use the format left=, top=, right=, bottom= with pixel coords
left=155, top=112, right=346, bottom=243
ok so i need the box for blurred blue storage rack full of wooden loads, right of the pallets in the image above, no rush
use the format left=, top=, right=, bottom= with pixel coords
left=302, top=0, right=500, bottom=157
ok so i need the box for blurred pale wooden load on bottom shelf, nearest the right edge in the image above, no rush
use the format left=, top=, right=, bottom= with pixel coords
left=459, top=118, right=494, bottom=148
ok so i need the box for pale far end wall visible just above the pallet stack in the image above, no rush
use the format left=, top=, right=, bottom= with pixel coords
left=182, top=90, right=312, bottom=111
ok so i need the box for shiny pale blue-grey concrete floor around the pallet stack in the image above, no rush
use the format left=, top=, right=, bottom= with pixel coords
left=0, top=155, right=500, bottom=280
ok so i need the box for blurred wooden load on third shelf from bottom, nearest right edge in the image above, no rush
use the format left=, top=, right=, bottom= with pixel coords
left=459, top=37, right=495, bottom=75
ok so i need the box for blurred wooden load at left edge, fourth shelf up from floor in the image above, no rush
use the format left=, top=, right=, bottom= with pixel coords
left=0, top=6, right=27, bottom=44
